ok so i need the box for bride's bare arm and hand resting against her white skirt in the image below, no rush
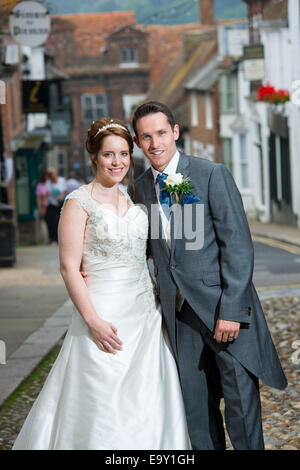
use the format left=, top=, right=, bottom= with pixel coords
left=58, top=199, right=122, bottom=353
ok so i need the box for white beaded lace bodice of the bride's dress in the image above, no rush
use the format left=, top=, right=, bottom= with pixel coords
left=66, top=185, right=148, bottom=269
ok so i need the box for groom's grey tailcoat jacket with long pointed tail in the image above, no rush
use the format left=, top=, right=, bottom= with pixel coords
left=129, top=154, right=287, bottom=389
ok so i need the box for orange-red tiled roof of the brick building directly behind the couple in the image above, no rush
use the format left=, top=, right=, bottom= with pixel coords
left=47, top=11, right=216, bottom=84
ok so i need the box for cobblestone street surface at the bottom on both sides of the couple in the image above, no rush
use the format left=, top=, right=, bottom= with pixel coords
left=0, top=296, right=300, bottom=450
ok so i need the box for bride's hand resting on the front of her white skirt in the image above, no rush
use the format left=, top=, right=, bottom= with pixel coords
left=88, top=318, right=122, bottom=354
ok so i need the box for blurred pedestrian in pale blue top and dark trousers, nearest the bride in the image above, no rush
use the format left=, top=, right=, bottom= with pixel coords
left=45, top=168, right=66, bottom=244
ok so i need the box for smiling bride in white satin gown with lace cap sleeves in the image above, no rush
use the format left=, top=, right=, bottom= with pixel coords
left=13, top=118, right=191, bottom=450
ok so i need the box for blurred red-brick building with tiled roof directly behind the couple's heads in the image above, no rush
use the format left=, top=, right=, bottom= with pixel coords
left=47, top=11, right=202, bottom=179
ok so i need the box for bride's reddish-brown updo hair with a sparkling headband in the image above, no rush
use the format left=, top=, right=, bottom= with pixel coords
left=85, top=117, right=134, bottom=180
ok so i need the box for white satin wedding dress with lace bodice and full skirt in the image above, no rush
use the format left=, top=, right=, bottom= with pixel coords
left=13, top=185, right=191, bottom=450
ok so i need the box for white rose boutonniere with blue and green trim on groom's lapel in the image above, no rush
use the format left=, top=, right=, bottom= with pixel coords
left=162, top=173, right=200, bottom=204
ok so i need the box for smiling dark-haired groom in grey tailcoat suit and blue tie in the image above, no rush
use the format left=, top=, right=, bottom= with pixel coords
left=130, top=102, right=287, bottom=450
